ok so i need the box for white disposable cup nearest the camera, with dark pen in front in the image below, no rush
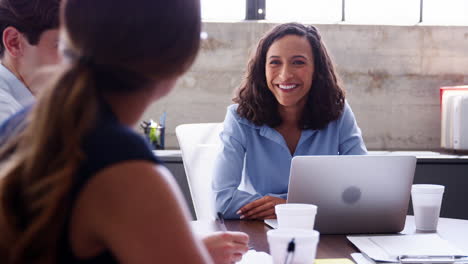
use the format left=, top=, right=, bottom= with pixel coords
left=267, top=228, right=319, bottom=264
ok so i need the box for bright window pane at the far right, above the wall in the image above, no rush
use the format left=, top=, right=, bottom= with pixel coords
left=423, top=0, right=468, bottom=25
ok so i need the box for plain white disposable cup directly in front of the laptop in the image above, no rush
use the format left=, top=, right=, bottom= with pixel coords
left=275, top=203, right=317, bottom=230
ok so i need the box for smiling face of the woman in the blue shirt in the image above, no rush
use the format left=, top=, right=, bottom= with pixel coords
left=265, top=35, right=314, bottom=111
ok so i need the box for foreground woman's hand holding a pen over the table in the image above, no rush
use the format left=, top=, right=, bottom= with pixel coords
left=203, top=232, right=249, bottom=264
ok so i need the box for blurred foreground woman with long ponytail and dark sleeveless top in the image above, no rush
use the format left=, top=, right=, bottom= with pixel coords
left=0, top=0, right=248, bottom=264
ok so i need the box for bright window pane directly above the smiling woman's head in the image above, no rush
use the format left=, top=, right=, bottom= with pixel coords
left=265, top=0, right=342, bottom=23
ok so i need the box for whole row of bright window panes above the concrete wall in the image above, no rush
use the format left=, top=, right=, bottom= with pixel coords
left=201, top=0, right=468, bottom=25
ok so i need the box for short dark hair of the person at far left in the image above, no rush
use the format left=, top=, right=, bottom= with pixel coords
left=0, top=0, right=61, bottom=57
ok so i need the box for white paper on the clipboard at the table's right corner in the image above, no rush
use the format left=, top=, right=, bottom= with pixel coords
left=347, top=234, right=463, bottom=261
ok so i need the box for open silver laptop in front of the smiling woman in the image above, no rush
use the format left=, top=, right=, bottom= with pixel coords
left=266, top=155, right=416, bottom=234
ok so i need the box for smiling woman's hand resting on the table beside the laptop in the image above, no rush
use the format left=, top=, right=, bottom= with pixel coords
left=237, top=196, right=286, bottom=219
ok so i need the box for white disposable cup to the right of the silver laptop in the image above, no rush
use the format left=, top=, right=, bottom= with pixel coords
left=411, top=184, right=445, bottom=231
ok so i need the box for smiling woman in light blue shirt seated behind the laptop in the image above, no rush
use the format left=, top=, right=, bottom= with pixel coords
left=213, top=23, right=367, bottom=219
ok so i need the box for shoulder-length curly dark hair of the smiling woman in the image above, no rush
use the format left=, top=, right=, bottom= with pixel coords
left=233, top=23, right=345, bottom=129
